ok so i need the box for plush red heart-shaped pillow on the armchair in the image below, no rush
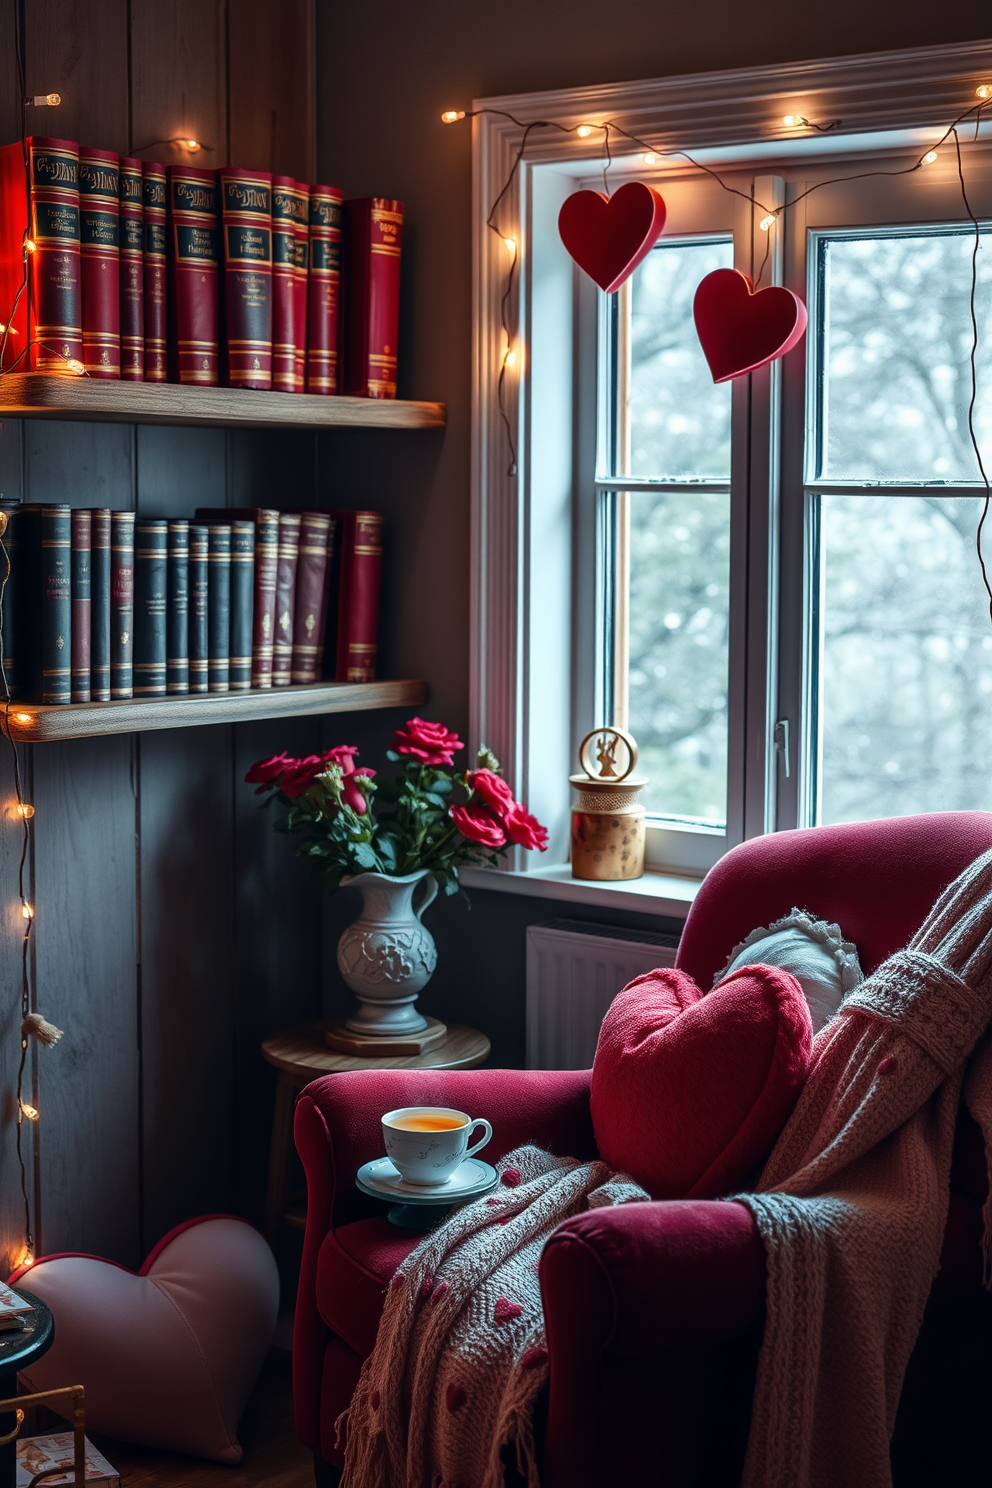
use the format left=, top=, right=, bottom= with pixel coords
left=592, top=966, right=812, bottom=1199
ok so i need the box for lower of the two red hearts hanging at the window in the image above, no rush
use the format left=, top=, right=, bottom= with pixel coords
left=693, top=269, right=806, bottom=382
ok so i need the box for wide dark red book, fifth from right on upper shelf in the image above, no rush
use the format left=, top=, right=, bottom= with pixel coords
left=220, top=167, right=272, bottom=390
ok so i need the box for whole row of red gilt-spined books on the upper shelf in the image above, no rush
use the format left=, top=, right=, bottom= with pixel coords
left=0, top=135, right=403, bottom=397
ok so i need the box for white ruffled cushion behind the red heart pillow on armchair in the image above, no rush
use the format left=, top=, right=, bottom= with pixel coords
left=714, top=909, right=864, bottom=1034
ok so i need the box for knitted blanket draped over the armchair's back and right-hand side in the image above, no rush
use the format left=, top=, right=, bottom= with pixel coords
left=738, top=853, right=992, bottom=1488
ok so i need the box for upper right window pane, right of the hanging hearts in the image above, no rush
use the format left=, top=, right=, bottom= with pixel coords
left=819, top=232, right=992, bottom=481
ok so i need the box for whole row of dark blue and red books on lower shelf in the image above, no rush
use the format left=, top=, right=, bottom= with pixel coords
left=0, top=503, right=382, bottom=704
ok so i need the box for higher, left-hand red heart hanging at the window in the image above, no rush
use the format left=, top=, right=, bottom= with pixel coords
left=558, top=182, right=665, bottom=295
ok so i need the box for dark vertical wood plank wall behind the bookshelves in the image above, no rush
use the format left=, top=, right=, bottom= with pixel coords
left=0, top=0, right=319, bottom=1274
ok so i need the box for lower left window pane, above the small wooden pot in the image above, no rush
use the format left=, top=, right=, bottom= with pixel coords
left=628, top=491, right=730, bottom=826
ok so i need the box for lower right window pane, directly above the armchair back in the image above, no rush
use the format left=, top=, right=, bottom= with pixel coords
left=819, top=496, right=992, bottom=821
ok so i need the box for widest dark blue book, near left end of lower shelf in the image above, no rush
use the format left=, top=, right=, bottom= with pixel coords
left=15, top=501, right=73, bottom=705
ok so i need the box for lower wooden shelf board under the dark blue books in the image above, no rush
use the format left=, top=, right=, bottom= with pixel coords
left=0, top=680, right=427, bottom=744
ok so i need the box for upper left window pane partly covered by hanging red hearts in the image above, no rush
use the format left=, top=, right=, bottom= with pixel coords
left=625, top=243, right=733, bottom=481
